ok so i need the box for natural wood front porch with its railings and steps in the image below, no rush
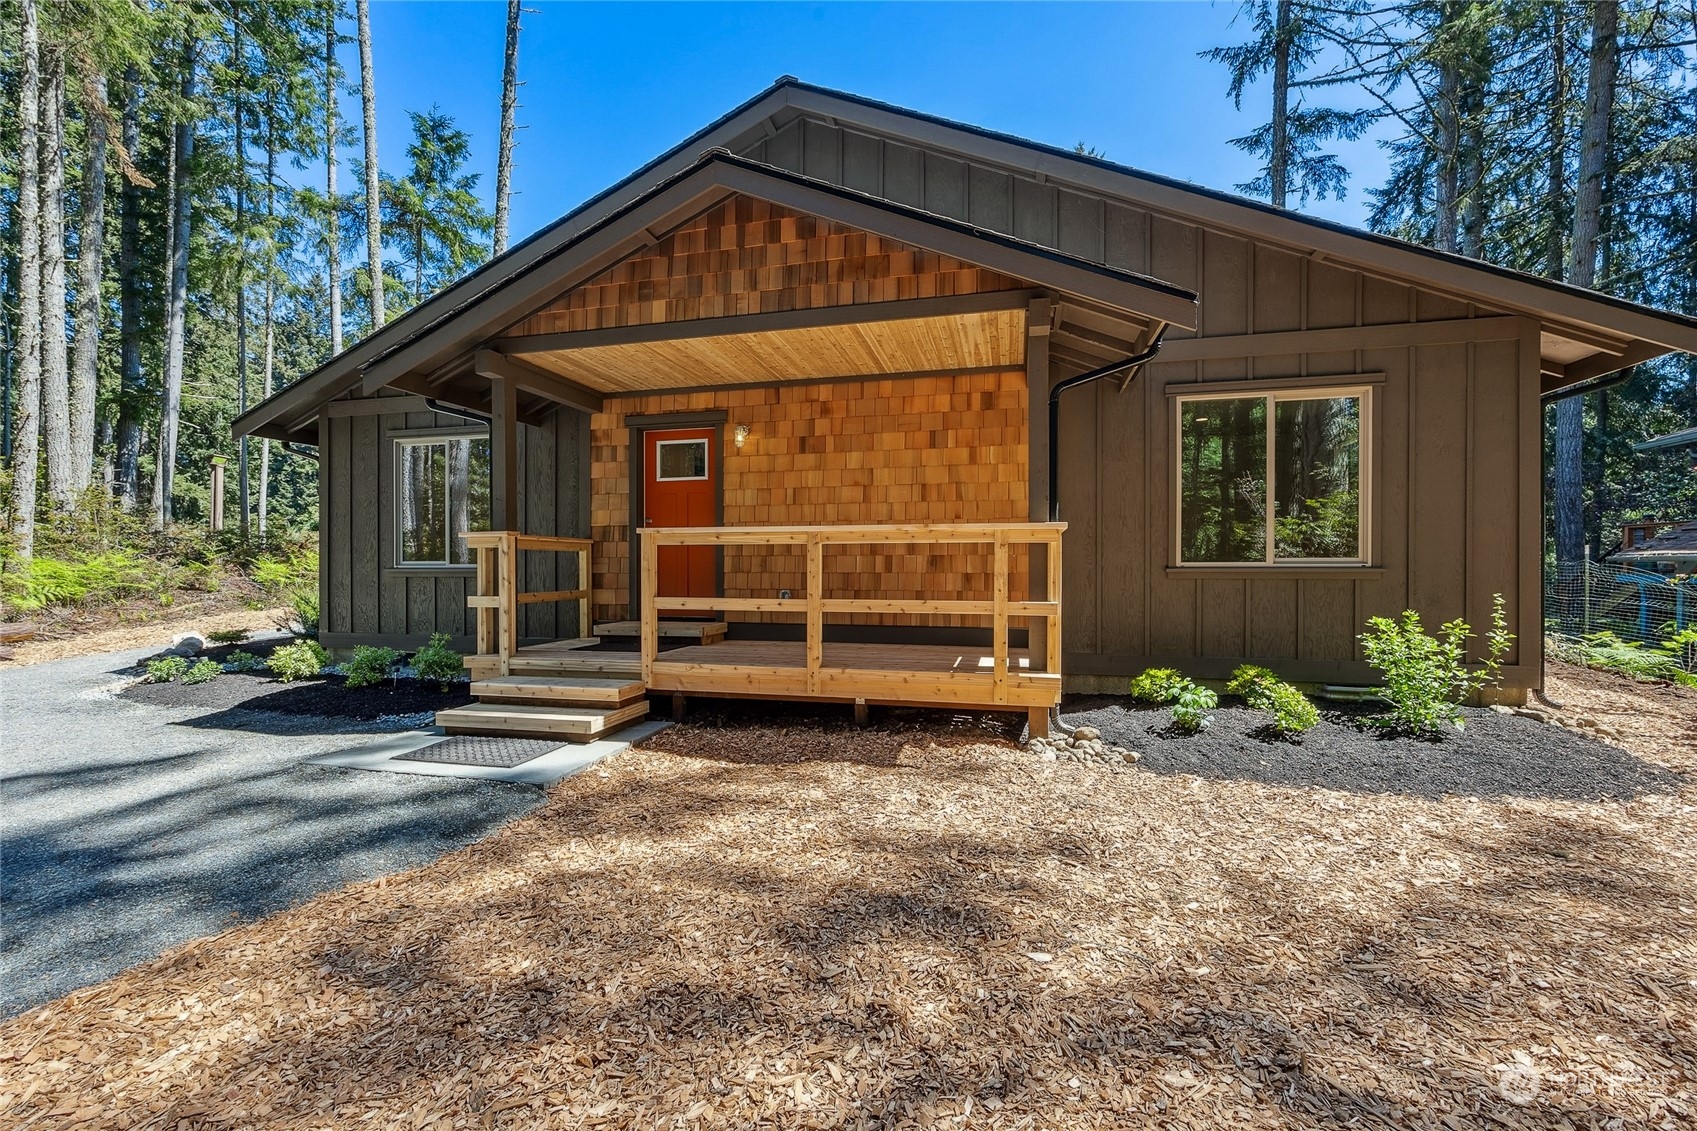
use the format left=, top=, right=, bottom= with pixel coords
left=438, top=523, right=1066, bottom=740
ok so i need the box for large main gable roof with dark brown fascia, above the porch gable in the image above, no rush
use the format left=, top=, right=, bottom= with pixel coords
left=234, top=76, right=1697, bottom=436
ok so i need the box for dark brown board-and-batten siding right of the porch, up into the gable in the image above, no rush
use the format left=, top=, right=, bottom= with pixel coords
left=747, top=117, right=1543, bottom=686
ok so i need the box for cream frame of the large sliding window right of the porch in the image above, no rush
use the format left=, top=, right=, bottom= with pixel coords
left=1173, top=384, right=1375, bottom=571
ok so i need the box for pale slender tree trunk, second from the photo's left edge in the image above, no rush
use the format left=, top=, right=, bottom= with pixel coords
left=39, top=48, right=76, bottom=511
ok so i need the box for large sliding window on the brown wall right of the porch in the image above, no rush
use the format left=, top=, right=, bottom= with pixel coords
left=1178, top=389, right=1369, bottom=566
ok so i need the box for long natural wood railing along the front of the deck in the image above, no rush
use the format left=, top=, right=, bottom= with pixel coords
left=638, top=523, right=1066, bottom=703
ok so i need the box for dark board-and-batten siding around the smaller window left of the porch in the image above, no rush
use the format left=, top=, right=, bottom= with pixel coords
left=319, top=397, right=589, bottom=652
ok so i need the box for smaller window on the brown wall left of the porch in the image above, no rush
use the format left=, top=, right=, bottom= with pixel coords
left=395, top=435, right=489, bottom=566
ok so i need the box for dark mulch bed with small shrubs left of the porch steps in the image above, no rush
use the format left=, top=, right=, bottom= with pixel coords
left=119, top=665, right=472, bottom=722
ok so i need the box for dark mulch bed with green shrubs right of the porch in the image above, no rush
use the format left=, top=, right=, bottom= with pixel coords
left=1062, top=696, right=1685, bottom=802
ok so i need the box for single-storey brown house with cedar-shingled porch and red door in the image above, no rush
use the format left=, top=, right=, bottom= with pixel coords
left=236, top=78, right=1697, bottom=737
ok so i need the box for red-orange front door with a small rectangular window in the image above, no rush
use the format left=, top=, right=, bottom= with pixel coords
left=643, top=428, right=720, bottom=616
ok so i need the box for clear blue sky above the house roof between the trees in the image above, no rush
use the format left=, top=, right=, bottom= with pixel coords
left=343, top=0, right=1385, bottom=243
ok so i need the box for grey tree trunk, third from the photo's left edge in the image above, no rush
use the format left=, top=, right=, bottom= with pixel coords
left=71, top=75, right=107, bottom=492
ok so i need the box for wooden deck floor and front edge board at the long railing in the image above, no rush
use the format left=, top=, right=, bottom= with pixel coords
left=648, top=640, right=1061, bottom=708
